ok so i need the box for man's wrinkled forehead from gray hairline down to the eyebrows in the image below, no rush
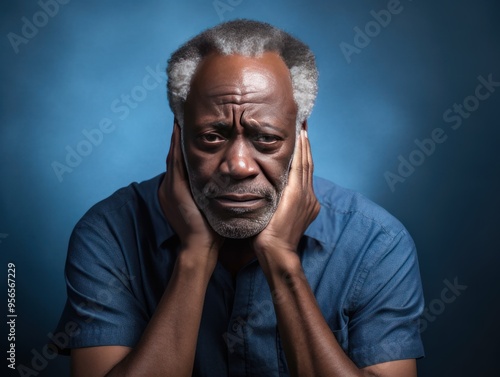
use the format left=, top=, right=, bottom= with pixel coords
left=186, top=52, right=297, bottom=122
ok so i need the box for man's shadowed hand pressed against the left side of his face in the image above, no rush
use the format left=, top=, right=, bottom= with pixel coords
left=160, top=123, right=223, bottom=268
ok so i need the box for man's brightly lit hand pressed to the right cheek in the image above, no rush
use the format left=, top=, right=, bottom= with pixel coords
left=253, top=130, right=320, bottom=267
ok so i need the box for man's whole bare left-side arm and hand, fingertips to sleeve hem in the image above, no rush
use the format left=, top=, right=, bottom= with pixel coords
left=71, top=124, right=223, bottom=377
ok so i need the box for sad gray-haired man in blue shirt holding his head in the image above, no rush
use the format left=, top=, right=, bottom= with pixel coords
left=60, top=20, right=423, bottom=377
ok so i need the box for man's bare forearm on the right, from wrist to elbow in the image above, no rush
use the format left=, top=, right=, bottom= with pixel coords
left=260, top=253, right=366, bottom=377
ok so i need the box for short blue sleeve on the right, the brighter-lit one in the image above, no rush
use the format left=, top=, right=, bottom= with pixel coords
left=349, top=230, right=424, bottom=368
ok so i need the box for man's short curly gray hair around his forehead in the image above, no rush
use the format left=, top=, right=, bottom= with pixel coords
left=167, top=20, right=318, bottom=127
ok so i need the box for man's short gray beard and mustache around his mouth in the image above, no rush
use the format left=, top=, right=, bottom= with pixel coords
left=188, top=172, right=288, bottom=239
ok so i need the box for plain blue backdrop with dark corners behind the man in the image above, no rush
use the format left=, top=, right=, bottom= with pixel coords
left=0, top=0, right=500, bottom=376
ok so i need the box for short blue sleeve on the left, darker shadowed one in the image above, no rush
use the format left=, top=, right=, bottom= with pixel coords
left=56, top=216, right=148, bottom=353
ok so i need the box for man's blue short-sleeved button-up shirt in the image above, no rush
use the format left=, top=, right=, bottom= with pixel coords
left=58, top=175, right=424, bottom=376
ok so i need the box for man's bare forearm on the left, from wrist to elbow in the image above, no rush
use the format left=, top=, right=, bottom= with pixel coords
left=106, top=252, right=213, bottom=377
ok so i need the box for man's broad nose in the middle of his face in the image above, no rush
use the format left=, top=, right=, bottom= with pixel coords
left=220, top=135, right=259, bottom=180
